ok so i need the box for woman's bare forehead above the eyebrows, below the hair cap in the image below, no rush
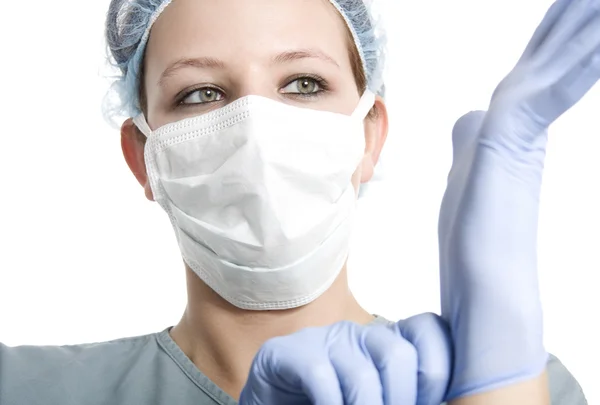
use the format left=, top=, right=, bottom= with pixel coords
left=147, top=0, right=349, bottom=71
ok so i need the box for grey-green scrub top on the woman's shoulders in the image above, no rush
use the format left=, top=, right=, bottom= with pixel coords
left=0, top=318, right=587, bottom=405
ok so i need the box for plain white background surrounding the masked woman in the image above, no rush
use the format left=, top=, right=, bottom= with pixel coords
left=0, top=0, right=600, bottom=404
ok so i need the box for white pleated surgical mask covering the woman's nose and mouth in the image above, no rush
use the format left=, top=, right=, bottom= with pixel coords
left=134, top=92, right=375, bottom=310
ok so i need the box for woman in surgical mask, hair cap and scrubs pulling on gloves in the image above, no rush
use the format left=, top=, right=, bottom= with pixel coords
left=0, top=0, right=600, bottom=405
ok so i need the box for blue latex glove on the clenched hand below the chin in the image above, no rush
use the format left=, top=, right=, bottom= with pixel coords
left=240, top=314, right=452, bottom=405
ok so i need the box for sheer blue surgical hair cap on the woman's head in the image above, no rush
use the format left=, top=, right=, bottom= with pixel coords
left=103, top=0, right=385, bottom=122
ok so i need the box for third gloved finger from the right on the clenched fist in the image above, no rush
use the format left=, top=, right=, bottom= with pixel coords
left=329, top=325, right=384, bottom=405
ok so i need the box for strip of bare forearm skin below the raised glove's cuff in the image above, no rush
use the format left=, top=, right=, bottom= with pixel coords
left=448, top=372, right=550, bottom=405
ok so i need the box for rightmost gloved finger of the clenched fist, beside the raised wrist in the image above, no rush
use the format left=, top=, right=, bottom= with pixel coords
left=396, top=313, right=453, bottom=405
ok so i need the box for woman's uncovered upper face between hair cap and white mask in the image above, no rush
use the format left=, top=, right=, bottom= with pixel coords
left=126, top=0, right=387, bottom=197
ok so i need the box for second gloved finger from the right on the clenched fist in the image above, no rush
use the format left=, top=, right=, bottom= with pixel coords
left=364, top=326, right=418, bottom=405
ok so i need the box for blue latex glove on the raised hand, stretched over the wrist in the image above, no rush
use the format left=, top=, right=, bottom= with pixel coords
left=439, top=0, right=600, bottom=399
